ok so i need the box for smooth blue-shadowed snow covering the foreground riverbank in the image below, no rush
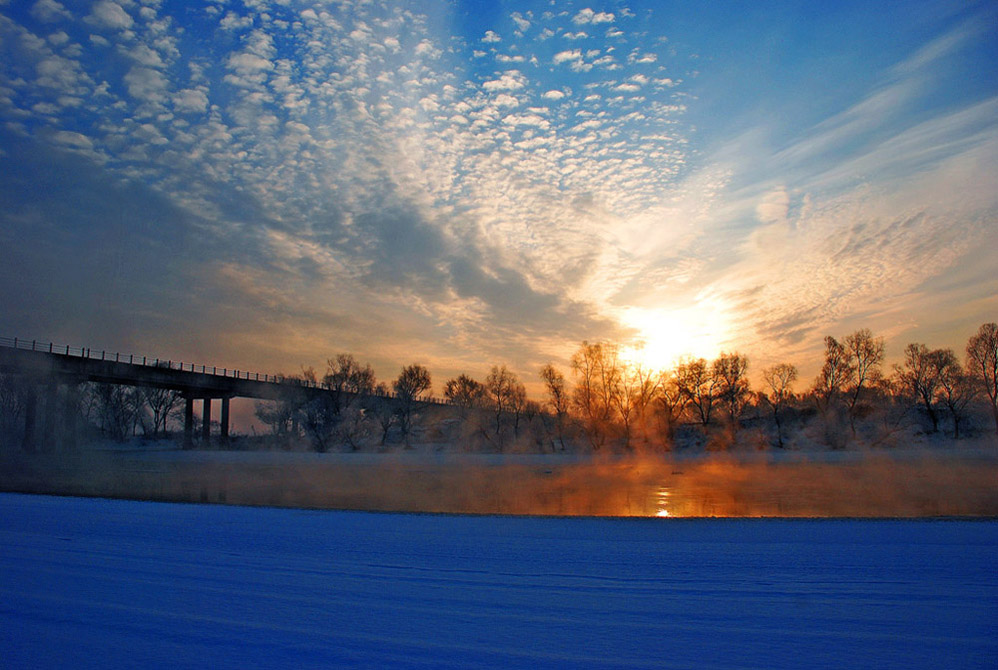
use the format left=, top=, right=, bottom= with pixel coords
left=0, top=494, right=998, bottom=668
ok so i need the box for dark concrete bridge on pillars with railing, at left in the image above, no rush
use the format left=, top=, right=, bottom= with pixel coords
left=0, top=337, right=442, bottom=450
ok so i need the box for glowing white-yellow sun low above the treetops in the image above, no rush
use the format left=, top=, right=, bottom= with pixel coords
left=621, top=299, right=730, bottom=370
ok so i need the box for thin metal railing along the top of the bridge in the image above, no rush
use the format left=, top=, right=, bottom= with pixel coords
left=0, top=337, right=449, bottom=405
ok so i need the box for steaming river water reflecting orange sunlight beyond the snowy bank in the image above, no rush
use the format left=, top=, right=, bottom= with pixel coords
left=0, top=451, right=998, bottom=518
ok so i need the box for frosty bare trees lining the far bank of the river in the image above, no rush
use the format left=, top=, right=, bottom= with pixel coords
left=0, top=323, right=998, bottom=452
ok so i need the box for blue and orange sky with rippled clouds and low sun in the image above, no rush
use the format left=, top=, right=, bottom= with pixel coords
left=0, top=0, right=998, bottom=392
